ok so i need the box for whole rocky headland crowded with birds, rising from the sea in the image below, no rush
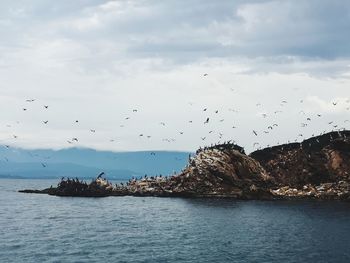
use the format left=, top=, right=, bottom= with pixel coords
left=20, top=131, right=350, bottom=200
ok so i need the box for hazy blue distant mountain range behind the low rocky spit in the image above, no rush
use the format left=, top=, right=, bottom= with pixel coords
left=0, top=146, right=190, bottom=179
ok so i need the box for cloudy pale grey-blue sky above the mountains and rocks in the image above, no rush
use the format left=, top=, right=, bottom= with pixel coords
left=0, top=0, right=350, bottom=152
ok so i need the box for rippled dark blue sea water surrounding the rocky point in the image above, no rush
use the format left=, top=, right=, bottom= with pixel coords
left=0, top=179, right=350, bottom=262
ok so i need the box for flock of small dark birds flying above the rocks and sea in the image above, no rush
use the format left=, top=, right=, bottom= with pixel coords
left=0, top=73, right=350, bottom=168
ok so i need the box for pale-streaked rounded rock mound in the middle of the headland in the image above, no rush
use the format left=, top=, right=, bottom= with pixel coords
left=171, top=145, right=274, bottom=198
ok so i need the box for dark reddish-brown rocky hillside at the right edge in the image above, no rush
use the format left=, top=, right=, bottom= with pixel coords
left=250, top=131, right=350, bottom=187
